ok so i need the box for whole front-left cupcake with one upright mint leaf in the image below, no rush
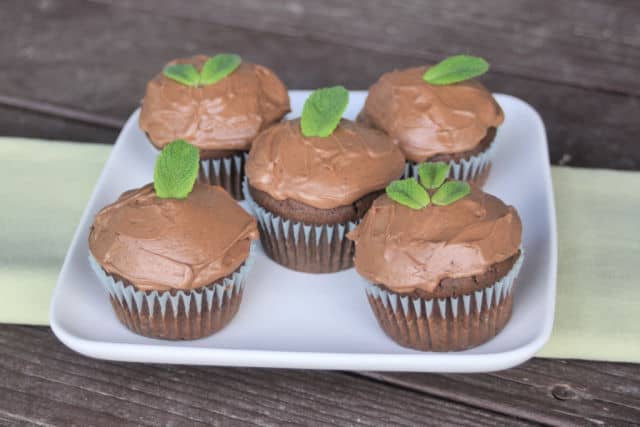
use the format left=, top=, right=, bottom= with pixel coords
left=89, top=141, right=258, bottom=340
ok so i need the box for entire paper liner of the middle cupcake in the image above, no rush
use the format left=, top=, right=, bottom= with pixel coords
left=243, top=179, right=358, bottom=273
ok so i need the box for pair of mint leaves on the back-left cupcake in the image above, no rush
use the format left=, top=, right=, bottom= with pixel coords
left=162, top=53, right=242, bottom=87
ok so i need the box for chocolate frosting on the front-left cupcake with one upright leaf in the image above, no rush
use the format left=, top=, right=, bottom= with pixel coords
left=89, top=184, right=258, bottom=290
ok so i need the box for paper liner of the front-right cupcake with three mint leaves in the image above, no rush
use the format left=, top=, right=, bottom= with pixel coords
left=366, top=250, right=524, bottom=351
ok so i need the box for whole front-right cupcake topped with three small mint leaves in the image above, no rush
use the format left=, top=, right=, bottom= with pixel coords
left=348, top=163, right=523, bottom=351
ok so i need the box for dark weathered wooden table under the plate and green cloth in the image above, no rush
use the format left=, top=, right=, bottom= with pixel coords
left=0, top=0, right=640, bottom=425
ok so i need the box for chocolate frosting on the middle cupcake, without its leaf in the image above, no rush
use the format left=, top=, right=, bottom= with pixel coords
left=246, top=119, right=405, bottom=209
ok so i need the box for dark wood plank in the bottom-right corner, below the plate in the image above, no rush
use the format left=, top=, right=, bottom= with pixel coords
left=364, top=359, right=640, bottom=425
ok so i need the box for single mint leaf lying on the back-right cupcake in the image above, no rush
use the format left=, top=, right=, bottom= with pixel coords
left=422, top=55, right=489, bottom=85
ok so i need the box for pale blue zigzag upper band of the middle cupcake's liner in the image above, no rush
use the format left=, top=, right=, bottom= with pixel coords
left=242, top=178, right=358, bottom=246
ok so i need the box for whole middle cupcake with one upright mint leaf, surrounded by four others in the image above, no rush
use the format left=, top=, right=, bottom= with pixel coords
left=245, top=86, right=405, bottom=273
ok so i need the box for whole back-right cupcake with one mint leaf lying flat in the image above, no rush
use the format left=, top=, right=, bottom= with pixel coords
left=358, top=55, right=504, bottom=185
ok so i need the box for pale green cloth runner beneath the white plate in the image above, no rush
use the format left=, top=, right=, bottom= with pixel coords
left=0, top=138, right=640, bottom=362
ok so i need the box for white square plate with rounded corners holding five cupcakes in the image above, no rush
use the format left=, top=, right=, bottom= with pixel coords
left=51, top=91, right=557, bottom=372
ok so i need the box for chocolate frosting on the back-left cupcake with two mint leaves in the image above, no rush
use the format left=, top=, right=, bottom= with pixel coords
left=139, top=55, right=290, bottom=151
